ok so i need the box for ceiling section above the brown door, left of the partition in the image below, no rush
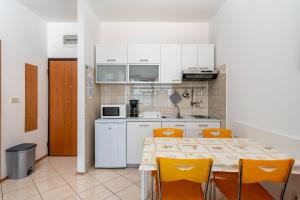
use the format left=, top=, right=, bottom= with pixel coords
left=19, top=0, right=77, bottom=22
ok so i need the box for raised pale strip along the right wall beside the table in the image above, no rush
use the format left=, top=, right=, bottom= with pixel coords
left=232, top=121, right=300, bottom=159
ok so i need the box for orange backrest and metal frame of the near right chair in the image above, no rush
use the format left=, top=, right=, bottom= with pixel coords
left=239, top=159, right=295, bottom=199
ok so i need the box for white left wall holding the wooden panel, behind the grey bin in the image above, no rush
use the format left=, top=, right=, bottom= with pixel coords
left=0, top=0, right=48, bottom=178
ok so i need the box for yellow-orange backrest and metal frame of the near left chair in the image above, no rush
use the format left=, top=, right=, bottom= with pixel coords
left=157, top=158, right=213, bottom=199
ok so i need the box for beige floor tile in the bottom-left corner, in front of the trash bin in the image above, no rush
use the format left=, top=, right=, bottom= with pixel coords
left=3, top=185, right=39, bottom=200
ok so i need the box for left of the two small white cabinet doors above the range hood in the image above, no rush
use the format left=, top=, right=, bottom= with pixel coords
left=182, top=44, right=198, bottom=70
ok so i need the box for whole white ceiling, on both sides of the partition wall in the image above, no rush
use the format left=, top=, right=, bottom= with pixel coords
left=19, top=0, right=224, bottom=22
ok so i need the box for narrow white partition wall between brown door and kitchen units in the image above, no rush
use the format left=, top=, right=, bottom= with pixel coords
left=77, top=0, right=99, bottom=172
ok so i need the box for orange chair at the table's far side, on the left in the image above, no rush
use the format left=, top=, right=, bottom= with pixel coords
left=151, top=128, right=183, bottom=198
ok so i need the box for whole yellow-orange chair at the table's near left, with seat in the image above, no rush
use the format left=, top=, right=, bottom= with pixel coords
left=157, top=158, right=213, bottom=200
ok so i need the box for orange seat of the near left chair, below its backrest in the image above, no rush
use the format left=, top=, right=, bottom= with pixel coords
left=162, top=180, right=204, bottom=200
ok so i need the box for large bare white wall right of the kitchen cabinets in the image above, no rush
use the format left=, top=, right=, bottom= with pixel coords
left=210, top=0, right=300, bottom=197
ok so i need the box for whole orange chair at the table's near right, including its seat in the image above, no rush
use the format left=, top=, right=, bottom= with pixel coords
left=213, top=159, right=294, bottom=200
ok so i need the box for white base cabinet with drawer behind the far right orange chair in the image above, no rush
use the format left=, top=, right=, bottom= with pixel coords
left=185, top=121, right=220, bottom=137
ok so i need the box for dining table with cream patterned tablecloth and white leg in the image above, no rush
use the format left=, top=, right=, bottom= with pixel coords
left=139, top=137, right=300, bottom=200
